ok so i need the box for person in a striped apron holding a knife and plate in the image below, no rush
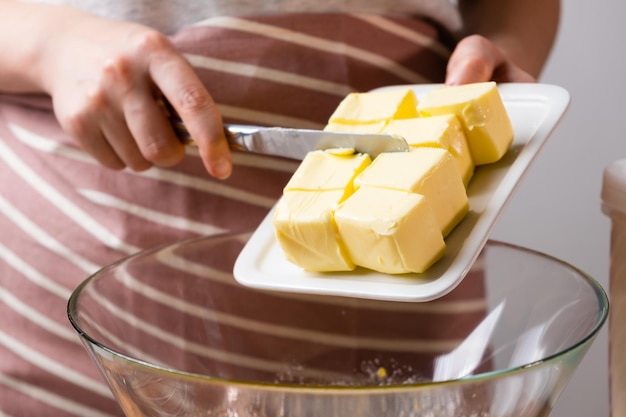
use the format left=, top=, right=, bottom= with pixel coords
left=0, top=0, right=559, bottom=416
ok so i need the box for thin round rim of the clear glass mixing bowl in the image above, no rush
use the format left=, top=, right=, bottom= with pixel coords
left=67, top=235, right=610, bottom=393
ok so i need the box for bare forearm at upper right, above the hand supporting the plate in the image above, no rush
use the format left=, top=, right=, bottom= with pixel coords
left=459, top=0, right=560, bottom=77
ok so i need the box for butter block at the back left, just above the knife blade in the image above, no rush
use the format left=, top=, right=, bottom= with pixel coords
left=328, top=89, right=418, bottom=125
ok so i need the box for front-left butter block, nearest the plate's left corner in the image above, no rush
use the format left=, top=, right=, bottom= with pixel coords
left=272, top=190, right=355, bottom=272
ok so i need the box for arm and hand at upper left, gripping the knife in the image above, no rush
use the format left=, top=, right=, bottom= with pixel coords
left=0, top=0, right=231, bottom=178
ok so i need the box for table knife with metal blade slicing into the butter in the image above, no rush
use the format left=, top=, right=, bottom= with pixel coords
left=172, top=121, right=409, bottom=160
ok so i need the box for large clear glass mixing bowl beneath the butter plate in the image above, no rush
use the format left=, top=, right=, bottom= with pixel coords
left=68, top=236, right=608, bottom=417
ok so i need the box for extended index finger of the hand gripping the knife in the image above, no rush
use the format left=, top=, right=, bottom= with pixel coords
left=150, top=53, right=232, bottom=179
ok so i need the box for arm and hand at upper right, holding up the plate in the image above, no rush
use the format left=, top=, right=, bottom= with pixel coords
left=446, top=0, right=560, bottom=84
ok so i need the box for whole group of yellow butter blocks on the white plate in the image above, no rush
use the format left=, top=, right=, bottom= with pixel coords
left=272, top=82, right=513, bottom=274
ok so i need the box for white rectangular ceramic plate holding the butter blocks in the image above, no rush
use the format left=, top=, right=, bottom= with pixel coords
left=234, top=83, right=570, bottom=302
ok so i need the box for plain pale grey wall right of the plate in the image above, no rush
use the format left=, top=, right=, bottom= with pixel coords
left=493, top=0, right=626, bottom=417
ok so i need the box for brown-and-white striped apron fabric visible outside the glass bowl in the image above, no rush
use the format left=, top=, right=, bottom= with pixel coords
left=0, top=14, right=483, bottom=417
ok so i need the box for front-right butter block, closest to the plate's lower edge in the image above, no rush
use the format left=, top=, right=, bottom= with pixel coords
left=335, top=187, right=445, bottom=274
